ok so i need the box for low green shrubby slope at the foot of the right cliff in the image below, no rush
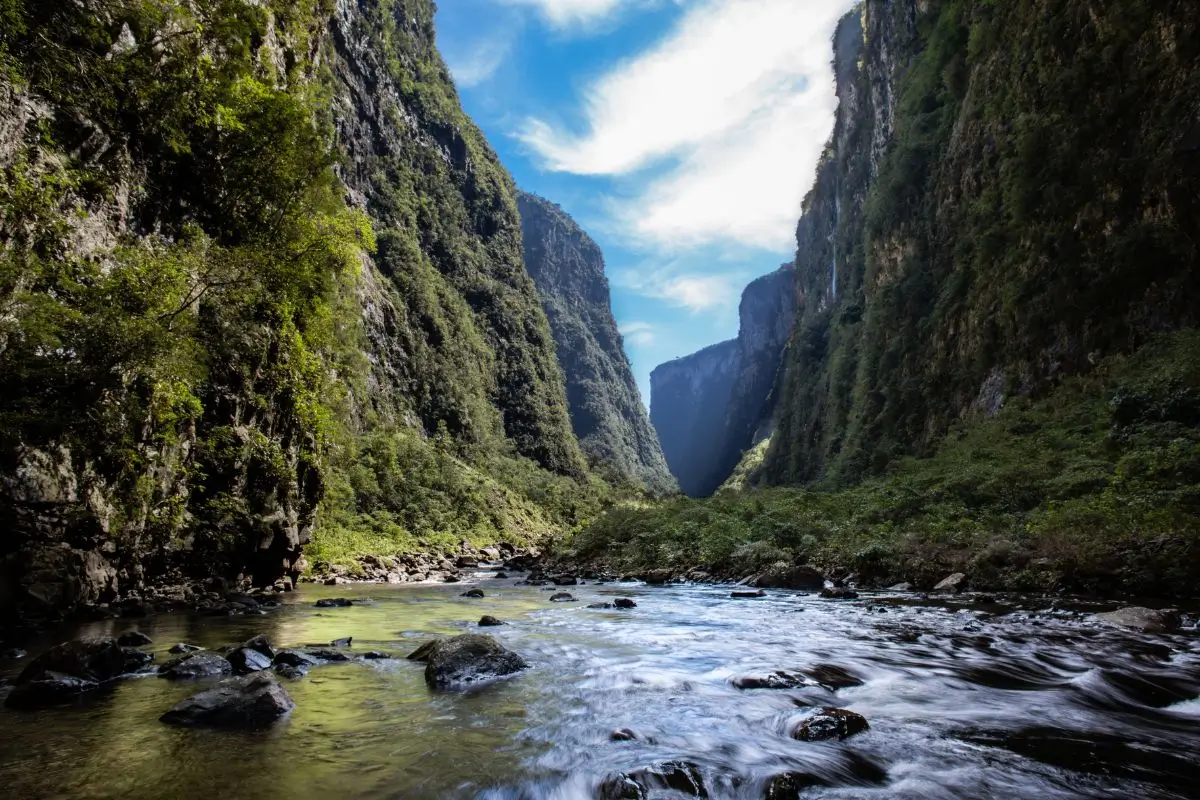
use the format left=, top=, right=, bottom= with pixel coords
left=566, top=331, right=1200, bottom=596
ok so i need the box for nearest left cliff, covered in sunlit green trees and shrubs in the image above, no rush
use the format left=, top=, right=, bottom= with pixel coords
left=0, top=0, right=586, bottom=614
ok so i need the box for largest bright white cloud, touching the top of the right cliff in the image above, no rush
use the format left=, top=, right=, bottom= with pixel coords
left=518, top=0, right=853, bottom=250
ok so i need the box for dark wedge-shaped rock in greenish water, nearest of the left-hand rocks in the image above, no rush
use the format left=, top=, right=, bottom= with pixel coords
left=160, top=673, right=295, bottom=729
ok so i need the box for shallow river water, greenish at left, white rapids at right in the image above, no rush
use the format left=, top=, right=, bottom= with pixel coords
left=0, top=579, right=1200, bottom=800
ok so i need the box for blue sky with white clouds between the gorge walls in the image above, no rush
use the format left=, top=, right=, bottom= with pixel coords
left=437, top=0, right=853, bottom=404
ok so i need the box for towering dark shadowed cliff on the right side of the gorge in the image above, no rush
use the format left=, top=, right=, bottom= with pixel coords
left=763, top=0, right=1200, bottom=482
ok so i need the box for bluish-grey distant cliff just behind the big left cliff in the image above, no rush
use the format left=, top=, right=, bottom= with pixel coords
left=517, top=192, right=678, bottom=493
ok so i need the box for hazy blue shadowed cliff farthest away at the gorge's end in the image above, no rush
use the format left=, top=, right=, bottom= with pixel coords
left=650, top=264, right=796, bottom=497
